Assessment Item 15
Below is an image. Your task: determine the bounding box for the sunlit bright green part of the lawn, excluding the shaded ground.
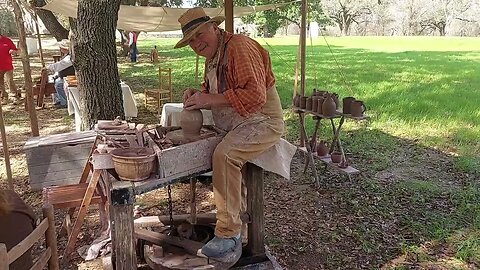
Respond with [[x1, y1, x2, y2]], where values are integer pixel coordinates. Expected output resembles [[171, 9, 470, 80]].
[[124, 37, 480, 171]]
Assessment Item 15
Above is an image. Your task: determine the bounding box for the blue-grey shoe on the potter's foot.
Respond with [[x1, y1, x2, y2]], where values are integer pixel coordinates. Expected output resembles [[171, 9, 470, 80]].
[[202, 234, 242, 261]]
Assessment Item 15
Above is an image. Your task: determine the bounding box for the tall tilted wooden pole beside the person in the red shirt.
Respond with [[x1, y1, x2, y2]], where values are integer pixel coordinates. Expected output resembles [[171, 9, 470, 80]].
[[10, 0, 39, 137]]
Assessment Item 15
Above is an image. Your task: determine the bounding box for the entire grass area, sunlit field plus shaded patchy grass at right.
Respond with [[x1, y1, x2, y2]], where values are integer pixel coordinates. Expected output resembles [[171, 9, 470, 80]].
[[119, 37, 480, 269]]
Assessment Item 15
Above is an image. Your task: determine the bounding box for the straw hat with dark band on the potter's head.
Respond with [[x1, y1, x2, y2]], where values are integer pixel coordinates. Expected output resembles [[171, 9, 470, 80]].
[[174, 7, 225, 49]]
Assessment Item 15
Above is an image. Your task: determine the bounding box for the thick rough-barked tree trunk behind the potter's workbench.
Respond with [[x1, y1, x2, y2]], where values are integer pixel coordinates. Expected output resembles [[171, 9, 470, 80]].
[[74, 0, 124, 129]]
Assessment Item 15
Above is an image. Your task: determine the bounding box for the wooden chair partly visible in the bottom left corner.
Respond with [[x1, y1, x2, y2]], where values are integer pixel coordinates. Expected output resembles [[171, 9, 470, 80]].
[[0, 205, 60, 270]]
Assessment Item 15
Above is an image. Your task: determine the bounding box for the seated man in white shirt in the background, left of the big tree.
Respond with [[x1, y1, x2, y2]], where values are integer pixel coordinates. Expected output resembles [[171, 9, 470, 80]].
[[48, 39, 75, 108]]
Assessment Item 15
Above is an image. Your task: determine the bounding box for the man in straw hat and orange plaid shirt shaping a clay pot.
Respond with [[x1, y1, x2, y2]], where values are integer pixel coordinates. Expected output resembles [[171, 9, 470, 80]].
[[175, 7, 284, 262]]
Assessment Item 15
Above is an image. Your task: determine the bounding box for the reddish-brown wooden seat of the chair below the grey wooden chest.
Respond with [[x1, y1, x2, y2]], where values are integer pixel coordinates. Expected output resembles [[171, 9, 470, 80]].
[[43, 183, 102, 209]]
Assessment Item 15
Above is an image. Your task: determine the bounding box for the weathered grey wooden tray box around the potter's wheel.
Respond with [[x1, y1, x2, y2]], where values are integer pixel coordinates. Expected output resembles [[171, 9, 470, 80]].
[[147, 126, 225, 178]]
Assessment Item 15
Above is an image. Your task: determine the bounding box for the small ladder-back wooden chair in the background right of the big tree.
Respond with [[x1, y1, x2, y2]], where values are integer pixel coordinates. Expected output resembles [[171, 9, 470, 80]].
[[145, 68, 173, 115]]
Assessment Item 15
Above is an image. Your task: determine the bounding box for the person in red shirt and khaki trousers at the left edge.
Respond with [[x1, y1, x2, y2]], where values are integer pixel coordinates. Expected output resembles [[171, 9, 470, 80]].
[[0, 32, 20, 101]]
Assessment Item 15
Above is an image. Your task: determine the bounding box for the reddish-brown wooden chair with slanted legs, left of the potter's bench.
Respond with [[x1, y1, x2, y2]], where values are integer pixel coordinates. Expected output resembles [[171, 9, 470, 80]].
[[43, 138, 108, 260]]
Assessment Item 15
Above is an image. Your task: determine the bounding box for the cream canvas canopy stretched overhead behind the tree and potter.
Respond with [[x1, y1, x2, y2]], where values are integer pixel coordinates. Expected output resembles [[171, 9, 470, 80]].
[[42, 0, 297, 32]]
